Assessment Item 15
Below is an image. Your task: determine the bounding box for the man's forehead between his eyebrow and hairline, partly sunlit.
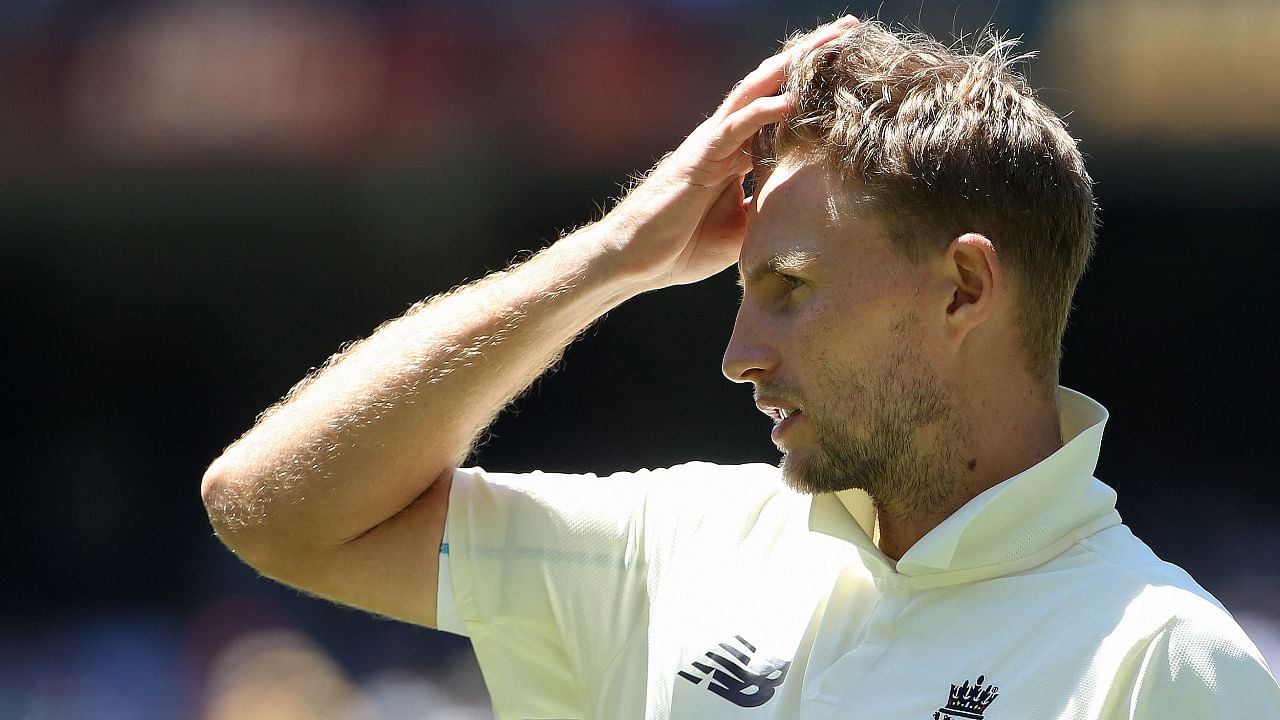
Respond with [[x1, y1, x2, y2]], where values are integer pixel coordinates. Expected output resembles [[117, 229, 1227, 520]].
[[739, 161, 890, 277]]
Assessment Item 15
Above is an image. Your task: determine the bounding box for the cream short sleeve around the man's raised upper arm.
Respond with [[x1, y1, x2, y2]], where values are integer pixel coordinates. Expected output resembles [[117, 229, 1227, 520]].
[[440, 461, 660, 717]]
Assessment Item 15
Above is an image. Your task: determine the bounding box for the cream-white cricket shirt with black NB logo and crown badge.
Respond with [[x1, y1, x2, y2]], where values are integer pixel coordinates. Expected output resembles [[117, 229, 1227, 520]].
[[439, 389, 1280, 720]]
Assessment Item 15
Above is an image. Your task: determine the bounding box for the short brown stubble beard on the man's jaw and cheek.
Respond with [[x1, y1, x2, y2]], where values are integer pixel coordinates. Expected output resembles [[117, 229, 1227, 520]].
[[783, 337, 968, 516]]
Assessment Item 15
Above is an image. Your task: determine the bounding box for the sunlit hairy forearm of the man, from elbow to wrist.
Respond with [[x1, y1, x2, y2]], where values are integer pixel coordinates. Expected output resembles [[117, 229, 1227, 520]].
[[202, 224, 641, 552]]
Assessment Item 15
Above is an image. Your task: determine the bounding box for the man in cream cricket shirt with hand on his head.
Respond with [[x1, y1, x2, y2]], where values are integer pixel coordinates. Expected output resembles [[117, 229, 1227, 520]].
[[202, 18, 1280, 720]]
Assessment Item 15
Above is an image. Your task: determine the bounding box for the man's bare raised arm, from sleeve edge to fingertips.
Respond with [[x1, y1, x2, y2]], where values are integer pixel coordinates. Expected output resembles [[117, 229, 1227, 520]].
[[201, 18, 854, 625]]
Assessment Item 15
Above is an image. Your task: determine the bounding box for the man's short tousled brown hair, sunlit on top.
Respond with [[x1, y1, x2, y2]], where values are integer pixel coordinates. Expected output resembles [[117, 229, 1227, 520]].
[[755, 22, 1097, 379]]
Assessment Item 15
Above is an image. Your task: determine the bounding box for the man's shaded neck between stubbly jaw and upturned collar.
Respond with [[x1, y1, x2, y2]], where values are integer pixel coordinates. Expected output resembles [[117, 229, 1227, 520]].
[[873, 387, 1062, 561]]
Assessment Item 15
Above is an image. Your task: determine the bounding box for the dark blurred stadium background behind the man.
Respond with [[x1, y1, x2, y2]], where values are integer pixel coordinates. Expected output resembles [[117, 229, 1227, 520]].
[[0, 0, 1280, 720]]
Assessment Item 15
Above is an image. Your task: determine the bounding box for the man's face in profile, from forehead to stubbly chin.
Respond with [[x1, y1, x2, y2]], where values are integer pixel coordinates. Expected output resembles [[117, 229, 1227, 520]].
[[723, 163, 965, 512]]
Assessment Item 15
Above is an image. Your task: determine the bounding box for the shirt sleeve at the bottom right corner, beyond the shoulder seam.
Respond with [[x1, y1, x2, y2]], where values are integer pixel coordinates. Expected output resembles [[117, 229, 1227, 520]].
[[1129, 611, 1280, 720]]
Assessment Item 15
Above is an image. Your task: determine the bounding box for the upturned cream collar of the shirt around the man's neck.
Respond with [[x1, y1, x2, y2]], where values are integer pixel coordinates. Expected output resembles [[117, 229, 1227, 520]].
[[809, 387, 1120, 584]]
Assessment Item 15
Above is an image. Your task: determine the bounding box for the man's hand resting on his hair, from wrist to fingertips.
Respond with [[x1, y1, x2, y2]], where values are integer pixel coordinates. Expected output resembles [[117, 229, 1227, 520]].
[[600, 15, 858, 290]]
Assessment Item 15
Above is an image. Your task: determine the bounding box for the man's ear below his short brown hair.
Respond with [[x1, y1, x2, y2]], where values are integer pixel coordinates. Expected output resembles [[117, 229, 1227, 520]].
[[943, 232, 1005, 340]]
